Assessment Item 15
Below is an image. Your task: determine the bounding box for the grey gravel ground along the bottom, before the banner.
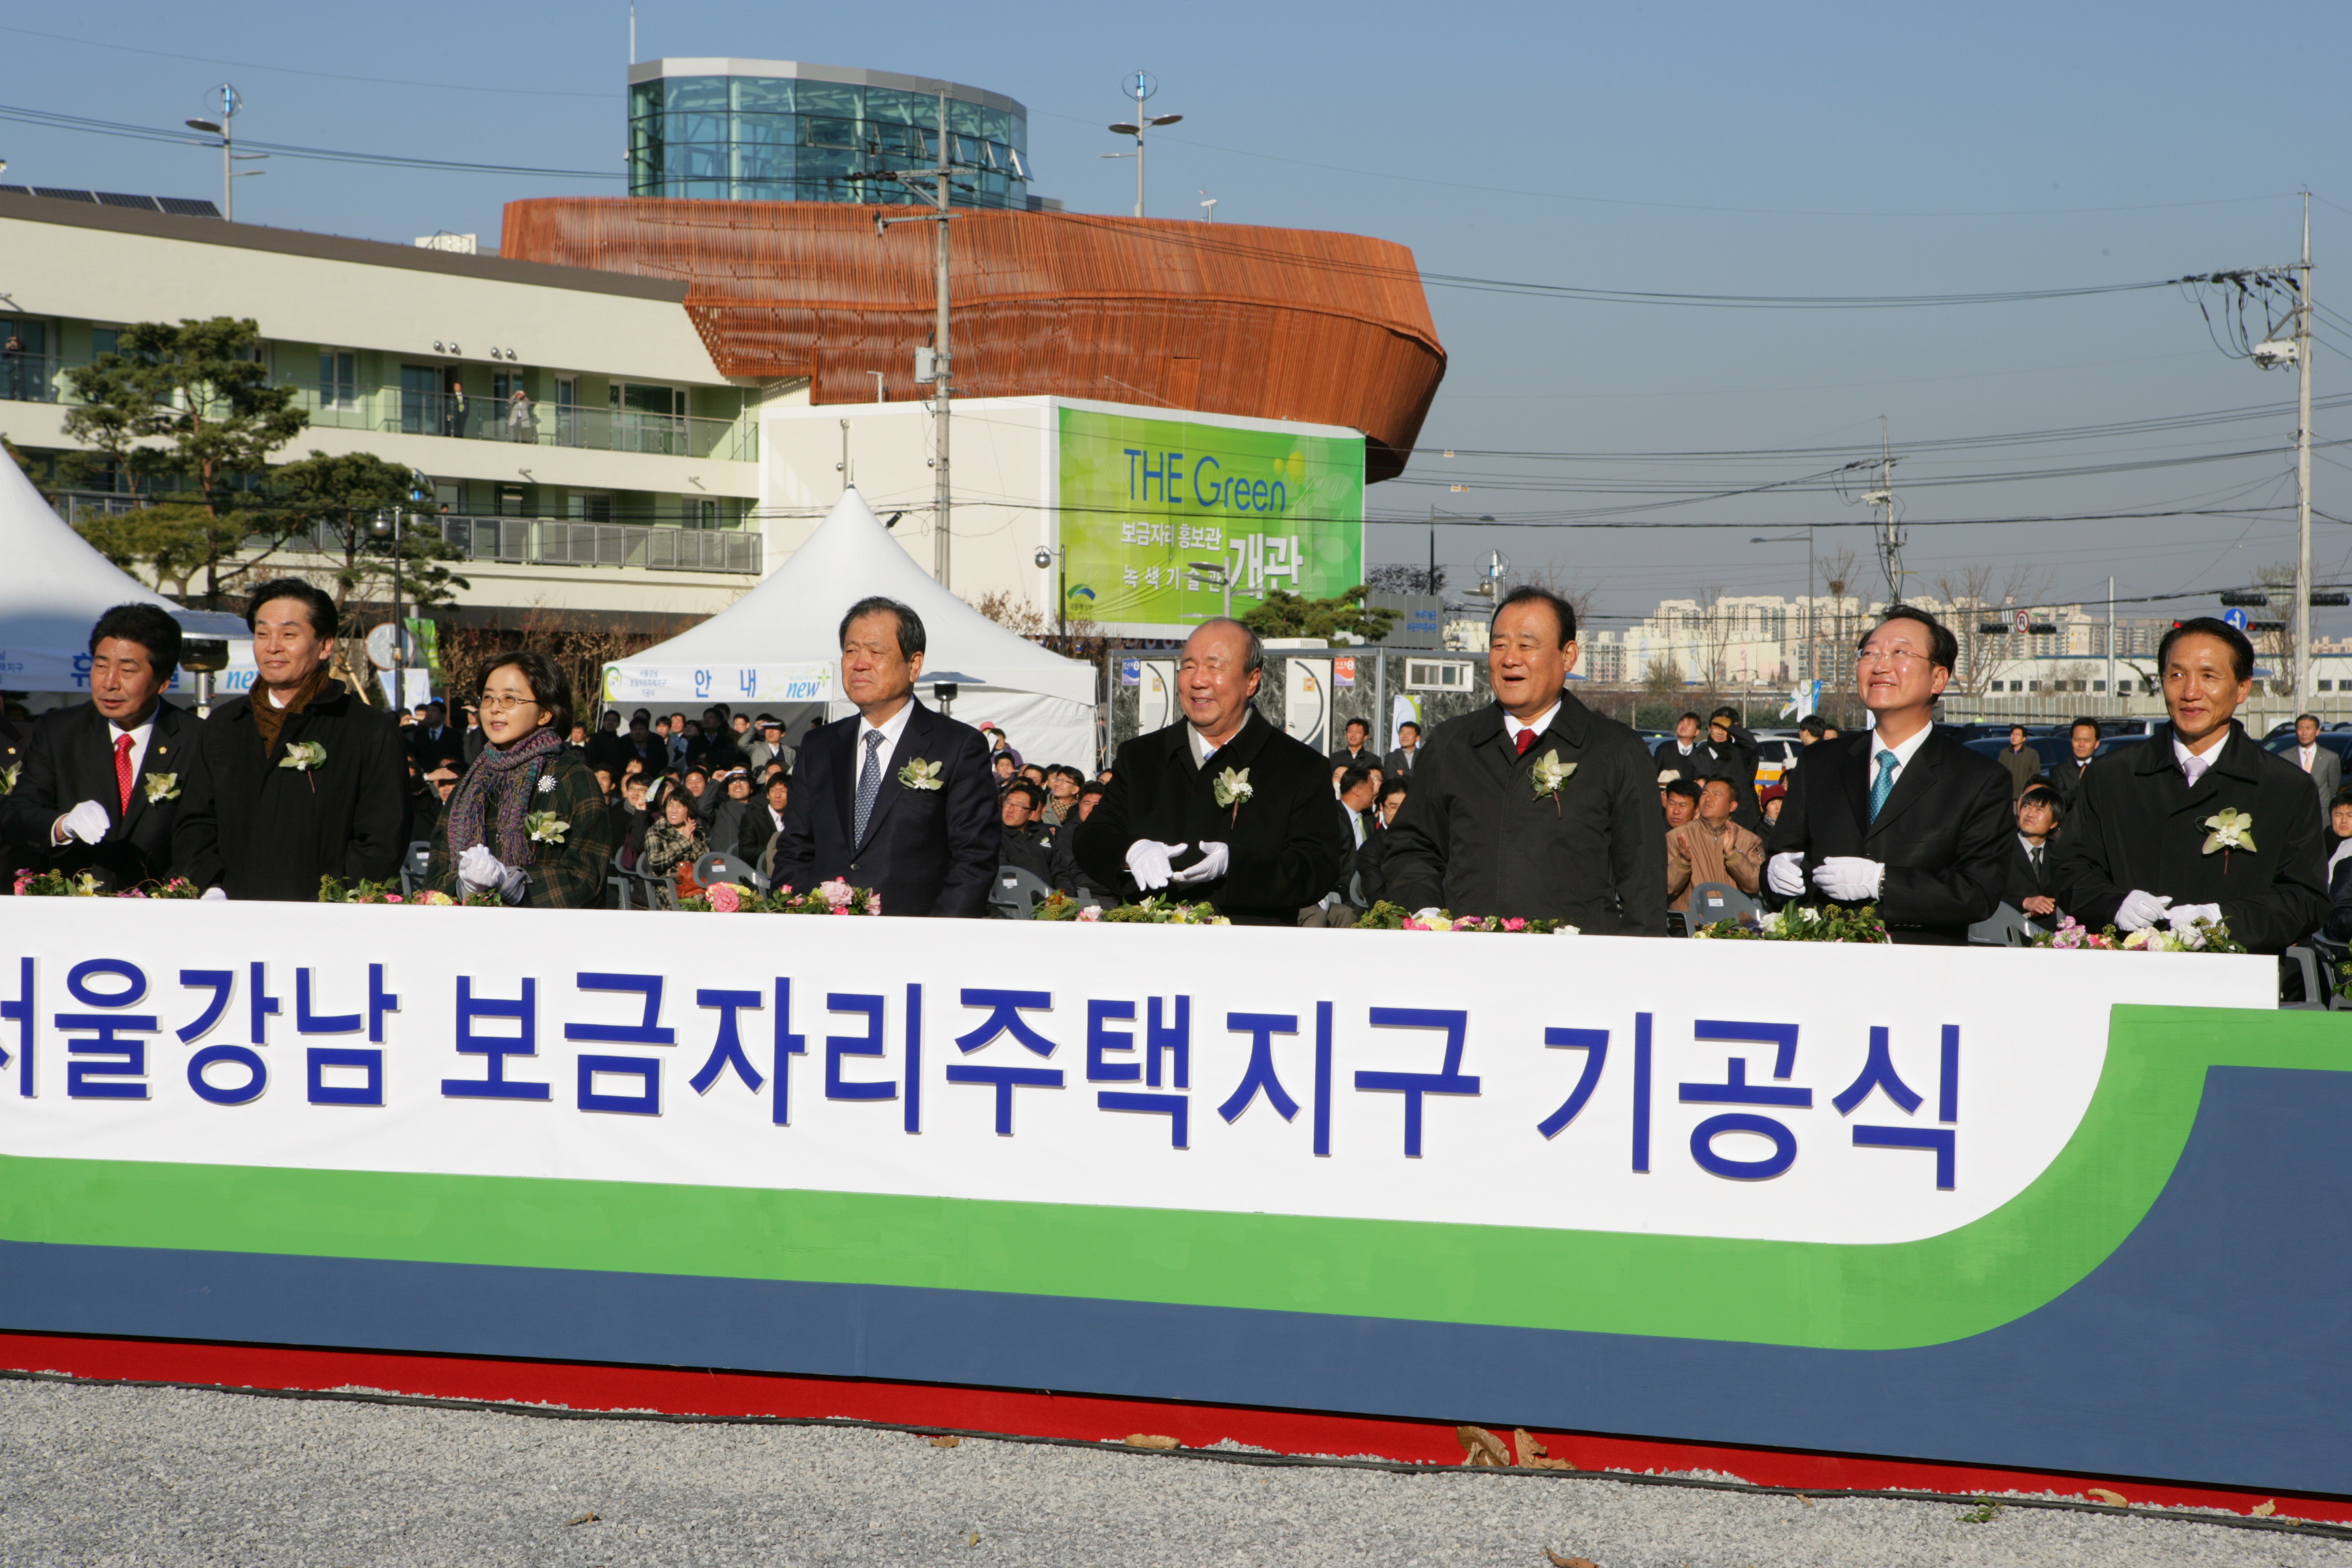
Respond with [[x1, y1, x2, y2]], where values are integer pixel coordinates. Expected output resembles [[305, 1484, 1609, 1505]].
[[0, 1382, 2352, 1568]]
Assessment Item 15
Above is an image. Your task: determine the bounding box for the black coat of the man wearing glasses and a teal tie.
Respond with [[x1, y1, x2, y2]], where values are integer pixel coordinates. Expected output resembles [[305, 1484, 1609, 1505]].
[[1767, 728, 2013, 945]]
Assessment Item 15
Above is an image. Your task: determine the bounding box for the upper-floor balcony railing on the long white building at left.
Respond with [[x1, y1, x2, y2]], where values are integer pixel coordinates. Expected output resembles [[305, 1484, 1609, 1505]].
[[0, 353, 760, 463]]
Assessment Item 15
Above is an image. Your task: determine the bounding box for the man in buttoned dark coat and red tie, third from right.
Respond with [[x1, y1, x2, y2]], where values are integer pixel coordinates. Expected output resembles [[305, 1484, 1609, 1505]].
[[1380, 588, 1665, 936]]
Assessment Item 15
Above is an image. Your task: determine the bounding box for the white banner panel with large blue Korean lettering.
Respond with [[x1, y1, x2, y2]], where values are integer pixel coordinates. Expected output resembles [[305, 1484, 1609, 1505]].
[[0, 898, 2274, 1243]]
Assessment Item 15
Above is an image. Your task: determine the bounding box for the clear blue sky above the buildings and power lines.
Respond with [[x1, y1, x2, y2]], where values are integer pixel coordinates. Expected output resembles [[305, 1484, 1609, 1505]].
[[0, 0, 2352, 630]]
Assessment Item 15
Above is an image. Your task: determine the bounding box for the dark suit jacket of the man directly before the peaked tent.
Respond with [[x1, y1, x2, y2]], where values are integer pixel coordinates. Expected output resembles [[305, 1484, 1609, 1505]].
[[774, 698, 1004, 919]]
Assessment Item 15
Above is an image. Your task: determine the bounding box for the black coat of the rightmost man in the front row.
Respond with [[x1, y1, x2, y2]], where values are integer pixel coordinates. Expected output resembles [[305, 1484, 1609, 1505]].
[[2055, 719, 2328, 952]]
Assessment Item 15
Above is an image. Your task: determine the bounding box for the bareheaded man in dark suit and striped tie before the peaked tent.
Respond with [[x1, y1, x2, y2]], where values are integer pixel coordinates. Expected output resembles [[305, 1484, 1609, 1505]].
[[776, 600, 1002, 917]]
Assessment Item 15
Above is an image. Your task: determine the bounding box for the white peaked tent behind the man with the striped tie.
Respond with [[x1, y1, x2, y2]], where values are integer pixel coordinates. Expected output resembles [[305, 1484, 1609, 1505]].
[[604, 487, 1096, 774]]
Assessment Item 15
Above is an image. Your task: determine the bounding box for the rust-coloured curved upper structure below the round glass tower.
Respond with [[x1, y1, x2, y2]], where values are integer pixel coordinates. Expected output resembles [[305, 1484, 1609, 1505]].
[[498, 197, 1446, 480]]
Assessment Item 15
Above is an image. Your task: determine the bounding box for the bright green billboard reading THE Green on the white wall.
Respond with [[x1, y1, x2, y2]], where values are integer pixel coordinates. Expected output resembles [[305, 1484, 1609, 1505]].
[[1061, 409, 1364, 625]]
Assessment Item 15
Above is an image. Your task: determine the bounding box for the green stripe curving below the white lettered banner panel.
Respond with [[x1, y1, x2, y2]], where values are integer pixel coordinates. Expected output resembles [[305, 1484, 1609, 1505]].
[[0, 1011, 2352, 1349]]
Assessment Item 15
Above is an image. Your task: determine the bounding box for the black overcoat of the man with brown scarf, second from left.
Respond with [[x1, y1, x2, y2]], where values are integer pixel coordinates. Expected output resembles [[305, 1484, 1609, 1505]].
[[172, 681, 407, 903]]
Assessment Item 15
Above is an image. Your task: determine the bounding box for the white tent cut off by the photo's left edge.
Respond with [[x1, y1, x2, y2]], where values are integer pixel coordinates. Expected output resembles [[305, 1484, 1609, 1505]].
[[0, 459, 252, 693]]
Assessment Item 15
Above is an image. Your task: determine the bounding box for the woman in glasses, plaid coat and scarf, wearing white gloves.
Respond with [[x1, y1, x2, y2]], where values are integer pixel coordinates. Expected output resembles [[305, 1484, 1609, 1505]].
[[426, 649, 612, 910]]
